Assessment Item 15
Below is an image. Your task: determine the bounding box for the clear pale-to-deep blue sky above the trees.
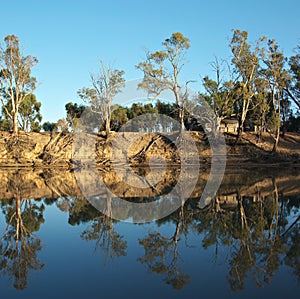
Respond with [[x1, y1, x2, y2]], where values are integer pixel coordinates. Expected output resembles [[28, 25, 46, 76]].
[[0, 0, 300, 121]]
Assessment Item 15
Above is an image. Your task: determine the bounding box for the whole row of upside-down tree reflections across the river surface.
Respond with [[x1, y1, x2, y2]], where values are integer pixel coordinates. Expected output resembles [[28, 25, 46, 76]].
[[0, 171, 300, 291]]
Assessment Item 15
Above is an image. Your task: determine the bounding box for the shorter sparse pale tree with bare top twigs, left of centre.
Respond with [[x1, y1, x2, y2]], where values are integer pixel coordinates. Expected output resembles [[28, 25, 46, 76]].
[[78, 61, 125, 136]]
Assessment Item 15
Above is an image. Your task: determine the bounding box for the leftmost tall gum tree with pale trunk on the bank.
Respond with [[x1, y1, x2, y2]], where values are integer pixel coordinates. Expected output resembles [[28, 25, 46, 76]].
[[0, 35, 38, 134]]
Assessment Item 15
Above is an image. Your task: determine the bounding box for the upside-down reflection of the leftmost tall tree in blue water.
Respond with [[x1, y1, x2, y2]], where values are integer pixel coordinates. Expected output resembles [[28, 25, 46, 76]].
[[0, 197, 44, 290]]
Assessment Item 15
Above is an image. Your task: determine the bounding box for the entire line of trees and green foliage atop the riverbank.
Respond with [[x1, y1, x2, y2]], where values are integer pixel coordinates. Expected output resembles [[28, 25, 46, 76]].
[[0, 29, 300, 139]]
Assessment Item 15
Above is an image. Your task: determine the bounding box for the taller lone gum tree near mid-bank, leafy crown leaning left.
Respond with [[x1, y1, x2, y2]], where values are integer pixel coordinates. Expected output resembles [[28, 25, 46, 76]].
[[137, 32, 190, 134]]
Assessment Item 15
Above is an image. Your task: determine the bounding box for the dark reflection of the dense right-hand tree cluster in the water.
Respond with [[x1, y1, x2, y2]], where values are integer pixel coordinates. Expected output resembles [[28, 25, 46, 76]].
[[193, 181, 300, 291]]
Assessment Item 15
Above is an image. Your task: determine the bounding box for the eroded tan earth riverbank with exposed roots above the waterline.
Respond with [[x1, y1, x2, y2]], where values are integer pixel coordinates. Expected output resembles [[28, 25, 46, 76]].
[[0, 132, 300, 169]]
